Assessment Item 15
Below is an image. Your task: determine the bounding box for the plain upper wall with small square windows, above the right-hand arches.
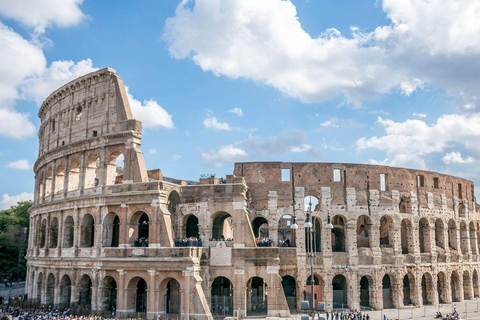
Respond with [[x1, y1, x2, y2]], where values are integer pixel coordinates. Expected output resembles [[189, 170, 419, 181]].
[[234, 162, 475, 211]]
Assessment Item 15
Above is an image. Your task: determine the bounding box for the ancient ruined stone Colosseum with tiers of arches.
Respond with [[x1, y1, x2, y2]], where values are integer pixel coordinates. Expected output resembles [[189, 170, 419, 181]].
[[26, 68, 480, 319]]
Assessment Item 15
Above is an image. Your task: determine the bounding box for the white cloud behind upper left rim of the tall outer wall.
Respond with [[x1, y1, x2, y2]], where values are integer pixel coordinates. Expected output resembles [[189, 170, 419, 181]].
[[21, 59, 98, 104]]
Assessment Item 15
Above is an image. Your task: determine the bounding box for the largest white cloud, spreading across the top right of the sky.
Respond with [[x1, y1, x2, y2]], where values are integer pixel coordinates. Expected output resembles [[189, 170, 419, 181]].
[[164, 0, 480, 109]]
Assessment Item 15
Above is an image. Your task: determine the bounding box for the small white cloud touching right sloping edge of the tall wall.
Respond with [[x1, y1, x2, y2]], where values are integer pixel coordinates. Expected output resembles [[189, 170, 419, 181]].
[[126, 87, 175, 129]]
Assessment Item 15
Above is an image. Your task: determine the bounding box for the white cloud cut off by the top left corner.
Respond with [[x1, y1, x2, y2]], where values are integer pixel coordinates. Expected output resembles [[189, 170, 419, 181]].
[[0, 0, 85, 34]]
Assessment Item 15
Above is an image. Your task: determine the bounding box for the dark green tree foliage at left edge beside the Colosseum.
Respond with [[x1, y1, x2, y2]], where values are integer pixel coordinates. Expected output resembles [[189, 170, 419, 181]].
[[0, 201, 32, 280]]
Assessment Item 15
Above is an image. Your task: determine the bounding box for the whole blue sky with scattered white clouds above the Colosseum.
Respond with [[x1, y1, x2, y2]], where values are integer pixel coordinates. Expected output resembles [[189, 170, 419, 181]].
[[0, 0, 480, 209]]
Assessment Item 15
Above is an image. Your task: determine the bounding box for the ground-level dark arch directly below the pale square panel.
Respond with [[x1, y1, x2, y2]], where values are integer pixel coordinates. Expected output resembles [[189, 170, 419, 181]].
[[211, 277, 233, 317]]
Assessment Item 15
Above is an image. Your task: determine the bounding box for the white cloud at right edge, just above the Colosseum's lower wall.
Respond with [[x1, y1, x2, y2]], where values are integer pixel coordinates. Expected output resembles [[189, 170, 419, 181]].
[[356, 114, 480, 168]]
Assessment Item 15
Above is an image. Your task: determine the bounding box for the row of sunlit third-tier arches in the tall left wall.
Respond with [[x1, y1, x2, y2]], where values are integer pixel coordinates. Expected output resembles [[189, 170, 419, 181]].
[[37, 150, 124, 199]]
